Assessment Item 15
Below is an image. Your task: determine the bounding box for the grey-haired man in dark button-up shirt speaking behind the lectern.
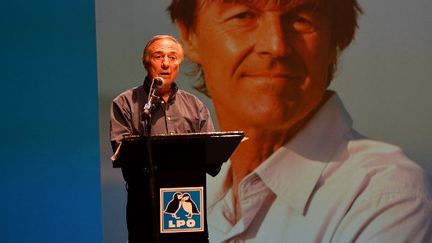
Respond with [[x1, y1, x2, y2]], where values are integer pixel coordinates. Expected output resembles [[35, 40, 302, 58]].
[[110, 35, 214, 243]]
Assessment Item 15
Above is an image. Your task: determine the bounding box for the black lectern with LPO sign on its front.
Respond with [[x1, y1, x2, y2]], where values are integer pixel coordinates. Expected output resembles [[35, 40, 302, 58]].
[[113, 131, 244, 243]]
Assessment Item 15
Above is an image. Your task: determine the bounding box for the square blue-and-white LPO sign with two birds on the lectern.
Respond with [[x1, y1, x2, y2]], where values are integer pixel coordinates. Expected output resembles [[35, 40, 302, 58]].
[[160, 187, 204, 233]]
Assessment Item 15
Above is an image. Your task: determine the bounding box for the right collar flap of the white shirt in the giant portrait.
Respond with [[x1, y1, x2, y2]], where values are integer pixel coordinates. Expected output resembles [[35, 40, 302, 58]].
[[255, 93, 352, 214]]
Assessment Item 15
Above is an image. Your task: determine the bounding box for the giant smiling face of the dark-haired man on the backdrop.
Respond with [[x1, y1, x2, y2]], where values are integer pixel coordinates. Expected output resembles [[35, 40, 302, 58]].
[[180, 1, 336, 129]]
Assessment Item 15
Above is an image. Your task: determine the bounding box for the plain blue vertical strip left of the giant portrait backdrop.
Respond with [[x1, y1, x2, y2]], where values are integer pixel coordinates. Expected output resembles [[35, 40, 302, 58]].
[[0, 0, 102, 243]]
